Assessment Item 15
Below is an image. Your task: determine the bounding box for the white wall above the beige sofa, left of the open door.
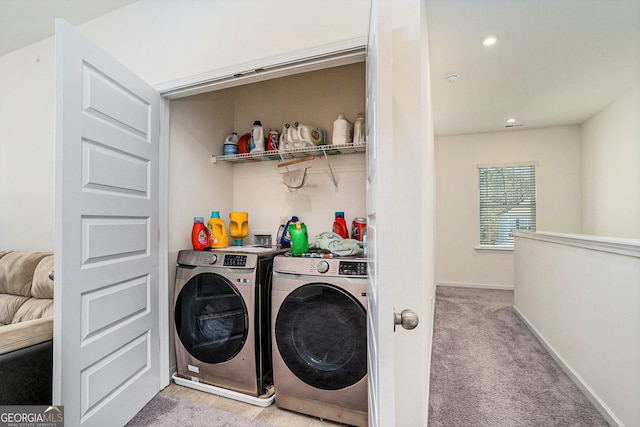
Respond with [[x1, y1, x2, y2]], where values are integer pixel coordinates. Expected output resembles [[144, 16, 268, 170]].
[[0, 39, 55, 251]]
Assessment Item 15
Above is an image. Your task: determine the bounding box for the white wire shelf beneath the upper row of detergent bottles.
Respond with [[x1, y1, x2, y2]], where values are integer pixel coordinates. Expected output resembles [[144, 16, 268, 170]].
[[211, 143, 367, 163]]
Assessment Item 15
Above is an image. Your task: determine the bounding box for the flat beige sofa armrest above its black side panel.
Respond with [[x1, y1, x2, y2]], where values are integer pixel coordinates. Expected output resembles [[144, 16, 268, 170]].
[[0, 317, 53, 354]]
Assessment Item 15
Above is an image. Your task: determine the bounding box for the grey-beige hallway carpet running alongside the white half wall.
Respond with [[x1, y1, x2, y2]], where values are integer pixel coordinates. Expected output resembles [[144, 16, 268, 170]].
[[429, 287, 608, 427]]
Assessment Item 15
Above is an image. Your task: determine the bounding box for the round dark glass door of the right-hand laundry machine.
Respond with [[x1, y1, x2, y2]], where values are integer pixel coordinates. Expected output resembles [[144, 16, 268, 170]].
[[275, 283, 367, 390]]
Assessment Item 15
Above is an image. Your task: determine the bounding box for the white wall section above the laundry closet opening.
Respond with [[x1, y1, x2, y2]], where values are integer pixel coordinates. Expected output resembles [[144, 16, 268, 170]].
[[79, 0, 369, 88]]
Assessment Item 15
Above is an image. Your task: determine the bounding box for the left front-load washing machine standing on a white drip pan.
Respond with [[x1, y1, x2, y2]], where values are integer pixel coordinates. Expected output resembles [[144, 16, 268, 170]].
[[173, 247, 283, 406]]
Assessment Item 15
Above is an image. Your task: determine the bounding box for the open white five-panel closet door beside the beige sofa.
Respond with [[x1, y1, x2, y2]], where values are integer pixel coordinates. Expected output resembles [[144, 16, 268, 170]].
[[53, 20, 160, 426]]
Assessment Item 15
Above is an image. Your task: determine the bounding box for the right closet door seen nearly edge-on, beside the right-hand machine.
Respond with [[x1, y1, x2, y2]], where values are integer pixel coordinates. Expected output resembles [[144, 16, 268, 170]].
[[366, 0, 395, 427]]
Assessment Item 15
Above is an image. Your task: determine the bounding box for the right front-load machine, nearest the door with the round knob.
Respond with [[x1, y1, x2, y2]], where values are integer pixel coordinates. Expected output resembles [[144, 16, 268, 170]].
[[271, 255, 368, 426]]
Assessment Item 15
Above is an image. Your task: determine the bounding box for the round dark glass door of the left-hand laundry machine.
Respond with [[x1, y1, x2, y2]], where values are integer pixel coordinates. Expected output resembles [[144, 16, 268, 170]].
[[175, 273, 249, 363]]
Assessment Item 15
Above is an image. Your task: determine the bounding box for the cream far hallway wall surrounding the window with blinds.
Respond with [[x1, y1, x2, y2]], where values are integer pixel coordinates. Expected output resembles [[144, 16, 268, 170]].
[[435, 126, 582, 287]]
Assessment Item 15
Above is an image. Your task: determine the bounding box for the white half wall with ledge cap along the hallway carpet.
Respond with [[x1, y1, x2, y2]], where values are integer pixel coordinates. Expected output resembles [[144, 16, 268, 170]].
[[514, 233, 640, 427]]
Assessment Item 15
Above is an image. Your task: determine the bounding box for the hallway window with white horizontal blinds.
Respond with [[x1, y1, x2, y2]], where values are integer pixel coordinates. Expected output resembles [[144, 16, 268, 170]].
[[478, 165, 536, 247]]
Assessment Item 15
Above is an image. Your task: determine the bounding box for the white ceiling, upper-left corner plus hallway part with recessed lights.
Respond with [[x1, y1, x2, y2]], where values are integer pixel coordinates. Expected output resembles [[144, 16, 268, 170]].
[[0, 0, 640, 135]]
